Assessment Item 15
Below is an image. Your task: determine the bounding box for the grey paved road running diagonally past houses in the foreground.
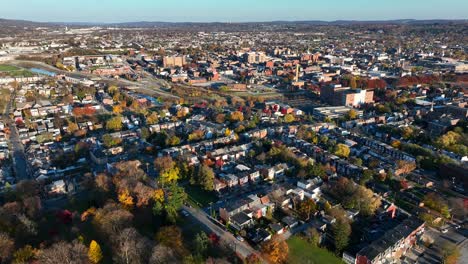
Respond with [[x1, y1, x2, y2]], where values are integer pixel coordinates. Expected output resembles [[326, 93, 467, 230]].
[[183, 206, 266, 263]]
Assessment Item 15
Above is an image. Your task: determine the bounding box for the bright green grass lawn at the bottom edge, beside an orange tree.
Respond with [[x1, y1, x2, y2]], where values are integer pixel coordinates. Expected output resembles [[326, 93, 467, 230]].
[[287, 236, 344, 264]]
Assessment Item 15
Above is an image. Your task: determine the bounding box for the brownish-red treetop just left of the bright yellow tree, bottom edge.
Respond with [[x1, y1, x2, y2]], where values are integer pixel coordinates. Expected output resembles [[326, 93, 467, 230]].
[[39, 240, 89, 264]]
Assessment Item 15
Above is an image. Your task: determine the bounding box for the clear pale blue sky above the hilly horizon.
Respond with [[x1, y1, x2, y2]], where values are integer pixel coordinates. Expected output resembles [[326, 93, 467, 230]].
[[0, 0, 468, 23]]
